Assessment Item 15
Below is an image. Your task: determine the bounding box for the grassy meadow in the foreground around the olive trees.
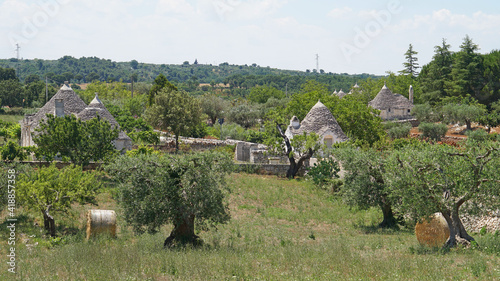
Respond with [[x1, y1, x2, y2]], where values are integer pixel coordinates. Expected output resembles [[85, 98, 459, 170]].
[[0, 174, 500, 280]]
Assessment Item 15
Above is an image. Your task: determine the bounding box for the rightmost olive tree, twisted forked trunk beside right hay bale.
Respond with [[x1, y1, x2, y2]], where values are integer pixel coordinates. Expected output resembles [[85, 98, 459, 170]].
[[387, 140, 500, 246]]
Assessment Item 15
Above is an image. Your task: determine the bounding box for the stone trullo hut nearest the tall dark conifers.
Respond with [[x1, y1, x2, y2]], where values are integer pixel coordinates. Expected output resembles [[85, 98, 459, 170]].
[[368, 84, 413, 120]]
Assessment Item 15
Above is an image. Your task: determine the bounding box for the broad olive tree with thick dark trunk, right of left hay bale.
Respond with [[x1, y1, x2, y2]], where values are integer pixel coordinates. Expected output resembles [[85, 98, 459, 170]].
[[105, 152, 231, 246]]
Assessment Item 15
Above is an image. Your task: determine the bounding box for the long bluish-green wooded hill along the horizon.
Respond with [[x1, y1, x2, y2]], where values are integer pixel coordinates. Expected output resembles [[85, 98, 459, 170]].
[[0, 56, 377, 89]]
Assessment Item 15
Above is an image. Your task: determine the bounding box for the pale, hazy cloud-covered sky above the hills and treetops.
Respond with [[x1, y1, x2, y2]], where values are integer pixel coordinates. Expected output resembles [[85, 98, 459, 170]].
[[0, 0, 500, 75]]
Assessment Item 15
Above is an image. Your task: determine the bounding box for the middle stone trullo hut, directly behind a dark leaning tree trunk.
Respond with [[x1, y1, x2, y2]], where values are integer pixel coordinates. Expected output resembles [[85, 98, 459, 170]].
[[285, 101, 349, 147]]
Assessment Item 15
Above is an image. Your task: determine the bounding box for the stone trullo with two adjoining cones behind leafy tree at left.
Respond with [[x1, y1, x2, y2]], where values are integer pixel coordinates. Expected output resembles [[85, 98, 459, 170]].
[[20, 82, 132, 151]]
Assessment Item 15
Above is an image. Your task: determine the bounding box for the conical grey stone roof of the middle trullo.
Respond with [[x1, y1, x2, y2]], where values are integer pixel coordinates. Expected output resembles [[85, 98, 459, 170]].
[[288, 101, 349, 141]]
